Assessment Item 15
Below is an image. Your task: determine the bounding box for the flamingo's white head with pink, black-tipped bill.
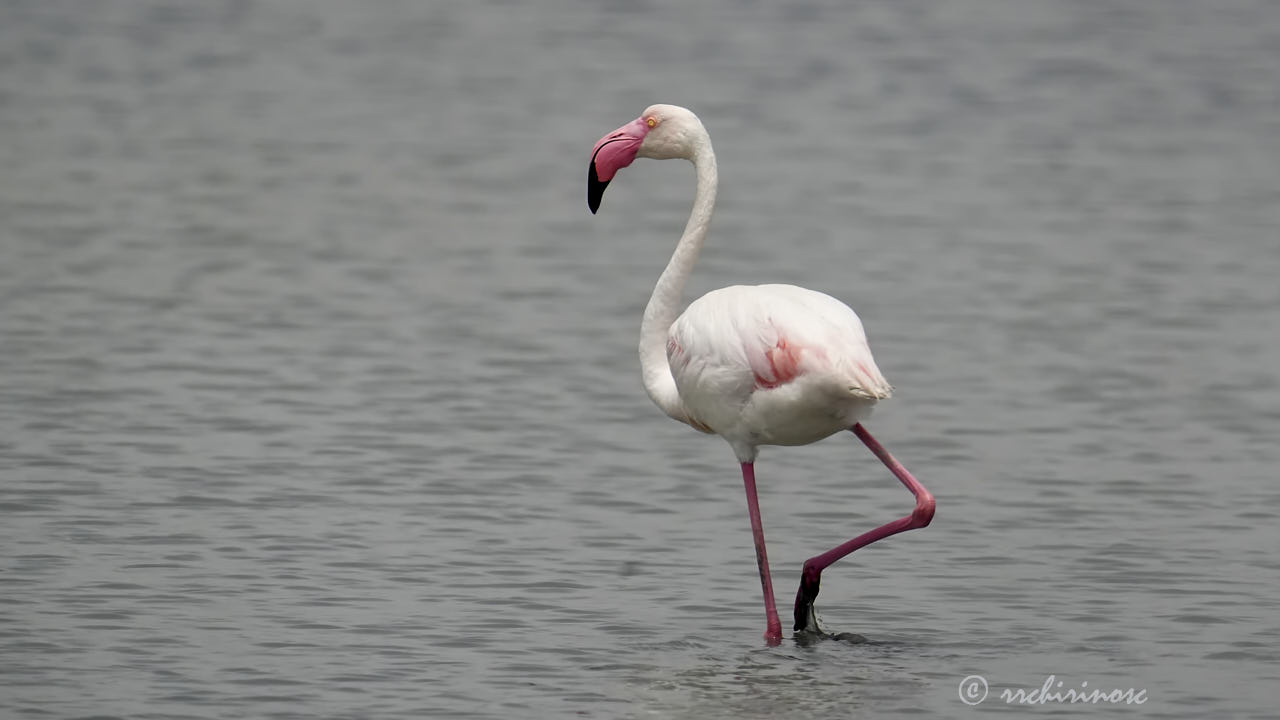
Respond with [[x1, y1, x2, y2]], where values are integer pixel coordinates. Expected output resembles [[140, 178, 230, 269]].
[[586, 105, 707, 214]]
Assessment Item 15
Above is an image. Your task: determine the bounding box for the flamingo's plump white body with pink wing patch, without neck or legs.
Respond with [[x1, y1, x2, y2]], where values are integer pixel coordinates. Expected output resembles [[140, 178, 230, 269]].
[[667, 284, 891, 462]]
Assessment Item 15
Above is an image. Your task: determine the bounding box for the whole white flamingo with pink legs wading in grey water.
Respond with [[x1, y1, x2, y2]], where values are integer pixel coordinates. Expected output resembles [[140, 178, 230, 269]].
[[586, 105, 934, 646]]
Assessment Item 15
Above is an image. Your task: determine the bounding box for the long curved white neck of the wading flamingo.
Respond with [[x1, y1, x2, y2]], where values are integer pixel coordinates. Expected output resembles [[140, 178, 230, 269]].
[[640, 131, 717, 421]]
